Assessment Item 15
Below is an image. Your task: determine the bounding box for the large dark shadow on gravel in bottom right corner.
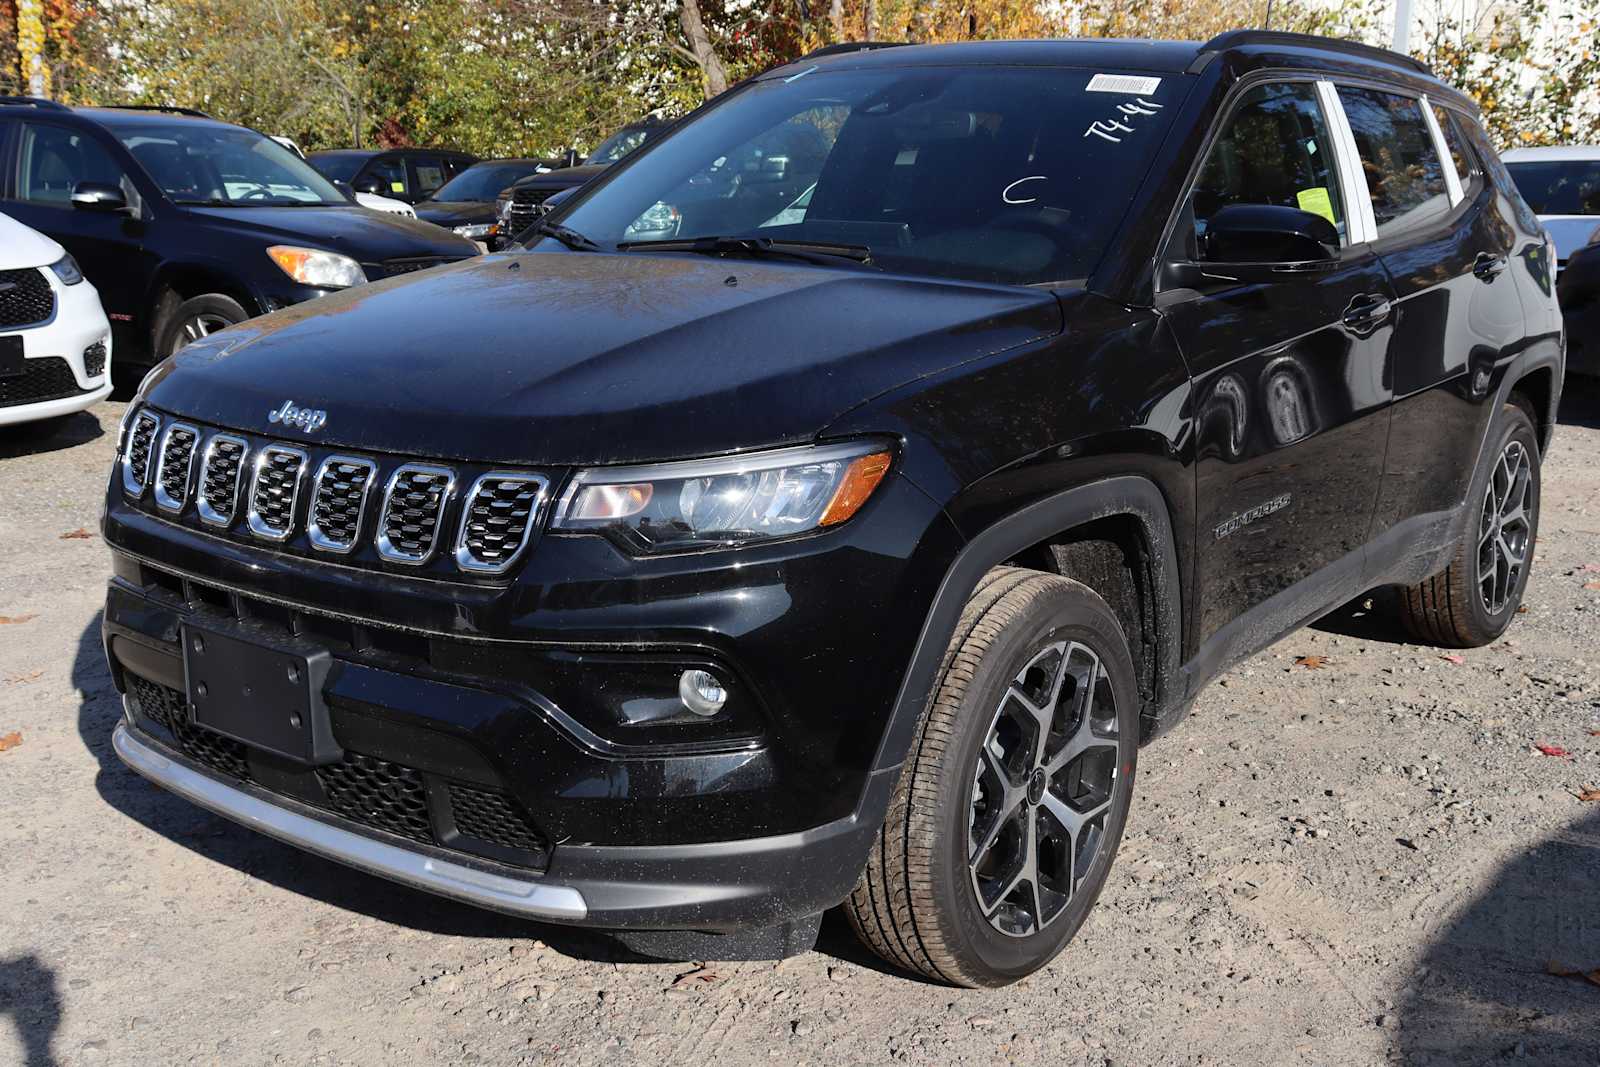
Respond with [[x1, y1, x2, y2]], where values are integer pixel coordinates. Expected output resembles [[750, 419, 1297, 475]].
[[1397, 806, 1600, 1067]]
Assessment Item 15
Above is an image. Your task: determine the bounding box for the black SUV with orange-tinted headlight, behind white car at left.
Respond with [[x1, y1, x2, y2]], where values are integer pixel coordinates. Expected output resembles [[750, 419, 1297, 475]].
[[0, 98, 478, 363]]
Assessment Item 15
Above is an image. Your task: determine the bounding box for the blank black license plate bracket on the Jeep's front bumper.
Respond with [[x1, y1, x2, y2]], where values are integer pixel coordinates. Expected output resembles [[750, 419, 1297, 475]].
[[179, 622, 344, 766]]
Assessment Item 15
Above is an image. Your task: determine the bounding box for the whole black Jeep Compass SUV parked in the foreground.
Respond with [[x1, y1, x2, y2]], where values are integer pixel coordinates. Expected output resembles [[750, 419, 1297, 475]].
[[104, 32, 1563, 984]]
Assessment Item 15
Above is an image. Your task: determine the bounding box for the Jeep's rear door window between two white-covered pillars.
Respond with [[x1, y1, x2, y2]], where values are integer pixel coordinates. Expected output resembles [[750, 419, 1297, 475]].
[[1339, 85, 1450, 240]]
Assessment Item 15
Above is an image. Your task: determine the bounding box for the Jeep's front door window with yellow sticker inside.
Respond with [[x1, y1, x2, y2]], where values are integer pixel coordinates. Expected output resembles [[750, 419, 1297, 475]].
[[1189, 82, 1349, 246]]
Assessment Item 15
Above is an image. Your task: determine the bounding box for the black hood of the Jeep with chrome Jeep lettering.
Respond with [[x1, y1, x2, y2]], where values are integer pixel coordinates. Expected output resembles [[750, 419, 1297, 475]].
[[140, 253, 1061, 466]]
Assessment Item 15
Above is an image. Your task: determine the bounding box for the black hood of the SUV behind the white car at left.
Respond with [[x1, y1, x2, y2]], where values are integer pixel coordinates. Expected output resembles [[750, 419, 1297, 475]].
[[186, 203, 478, 262]]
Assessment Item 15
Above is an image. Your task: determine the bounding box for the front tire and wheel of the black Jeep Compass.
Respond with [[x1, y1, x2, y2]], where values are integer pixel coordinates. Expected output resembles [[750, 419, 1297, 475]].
[[845, 568, 1139, 985]]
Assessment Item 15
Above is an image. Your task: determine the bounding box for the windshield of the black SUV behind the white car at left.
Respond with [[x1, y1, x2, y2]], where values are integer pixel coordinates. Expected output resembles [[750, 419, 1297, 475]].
[[107, 122, 349, 206]]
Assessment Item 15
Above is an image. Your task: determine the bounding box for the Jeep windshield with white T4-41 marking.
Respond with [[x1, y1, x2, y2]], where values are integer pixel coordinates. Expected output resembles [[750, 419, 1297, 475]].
[[558, 67, 1182, 285]]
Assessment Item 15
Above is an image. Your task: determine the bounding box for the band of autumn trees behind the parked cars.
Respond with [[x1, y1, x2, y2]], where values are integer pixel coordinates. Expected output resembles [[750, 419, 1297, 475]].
[[12, 0, 1600, 155]]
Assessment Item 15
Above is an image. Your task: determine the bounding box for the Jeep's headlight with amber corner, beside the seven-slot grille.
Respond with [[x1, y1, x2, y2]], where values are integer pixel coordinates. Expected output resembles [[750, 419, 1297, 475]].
[[555, 442, 893, 552]]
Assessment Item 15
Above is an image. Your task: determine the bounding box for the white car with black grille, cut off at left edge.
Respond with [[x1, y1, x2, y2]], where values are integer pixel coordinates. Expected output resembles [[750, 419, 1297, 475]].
[[0, 214, 110, 426]]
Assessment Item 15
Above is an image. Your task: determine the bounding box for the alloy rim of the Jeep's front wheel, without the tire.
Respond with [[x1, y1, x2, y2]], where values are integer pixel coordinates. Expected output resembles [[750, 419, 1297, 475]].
[[968, 641, 1118, 937]]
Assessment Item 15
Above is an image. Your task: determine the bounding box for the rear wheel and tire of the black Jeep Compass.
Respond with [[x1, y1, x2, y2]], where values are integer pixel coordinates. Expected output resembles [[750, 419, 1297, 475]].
[[1400, 403, 1539, 648]]
